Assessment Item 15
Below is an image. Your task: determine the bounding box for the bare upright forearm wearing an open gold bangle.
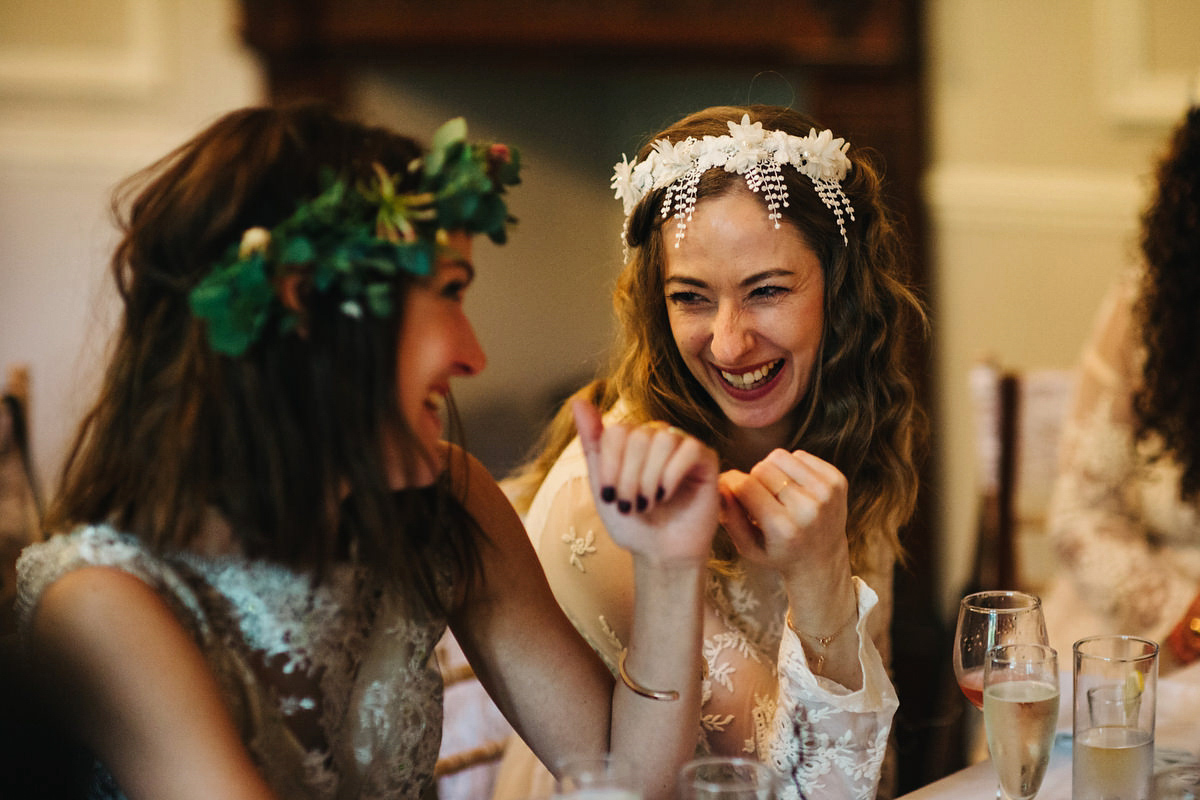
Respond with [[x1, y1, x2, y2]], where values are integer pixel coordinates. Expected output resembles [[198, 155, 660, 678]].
[[612, 559, 706, 800]]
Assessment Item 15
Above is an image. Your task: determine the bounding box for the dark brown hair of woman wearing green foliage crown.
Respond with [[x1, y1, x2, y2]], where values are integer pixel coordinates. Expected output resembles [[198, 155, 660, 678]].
[[47, 104, 479, 612]]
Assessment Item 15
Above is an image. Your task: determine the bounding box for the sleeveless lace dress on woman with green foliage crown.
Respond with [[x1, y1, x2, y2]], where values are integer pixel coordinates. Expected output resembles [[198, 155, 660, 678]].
[[18, 525, 445, 800]]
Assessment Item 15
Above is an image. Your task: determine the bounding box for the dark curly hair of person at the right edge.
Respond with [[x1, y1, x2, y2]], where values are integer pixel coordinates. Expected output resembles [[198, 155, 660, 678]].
[[1134, 107, 1200, 500]]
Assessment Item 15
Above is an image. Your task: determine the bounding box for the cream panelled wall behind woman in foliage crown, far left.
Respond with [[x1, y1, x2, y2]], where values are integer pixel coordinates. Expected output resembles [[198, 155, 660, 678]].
[[0, 0, 263, 488]]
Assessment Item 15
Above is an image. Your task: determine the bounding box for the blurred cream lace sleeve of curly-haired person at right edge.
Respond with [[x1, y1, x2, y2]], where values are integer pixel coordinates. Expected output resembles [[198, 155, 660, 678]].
[[1048, 282, 1196, 639]]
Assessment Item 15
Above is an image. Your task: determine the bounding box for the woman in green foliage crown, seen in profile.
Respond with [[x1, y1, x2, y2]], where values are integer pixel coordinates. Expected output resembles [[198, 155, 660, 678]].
[[11, 106, 719, 800]]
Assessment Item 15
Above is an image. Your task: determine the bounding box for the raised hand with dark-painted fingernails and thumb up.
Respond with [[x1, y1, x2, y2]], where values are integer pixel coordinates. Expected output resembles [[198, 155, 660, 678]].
[[571, 399, 720, 565]]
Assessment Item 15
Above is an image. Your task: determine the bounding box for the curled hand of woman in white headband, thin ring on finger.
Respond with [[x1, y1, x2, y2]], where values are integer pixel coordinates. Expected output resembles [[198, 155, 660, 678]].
[[720, 450, 850, 583]]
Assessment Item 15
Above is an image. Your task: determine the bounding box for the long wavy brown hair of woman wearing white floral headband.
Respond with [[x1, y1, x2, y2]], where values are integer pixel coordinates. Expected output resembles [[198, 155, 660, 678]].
[[512, 106, 928, 571]]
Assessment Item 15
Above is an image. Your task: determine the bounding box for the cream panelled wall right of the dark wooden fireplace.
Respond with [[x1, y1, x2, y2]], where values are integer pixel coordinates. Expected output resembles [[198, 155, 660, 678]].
[[926, 0, 1200, 613]]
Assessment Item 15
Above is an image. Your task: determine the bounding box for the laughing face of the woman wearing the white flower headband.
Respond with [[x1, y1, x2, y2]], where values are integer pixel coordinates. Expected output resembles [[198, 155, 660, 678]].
[[662, 190, 824, 445]]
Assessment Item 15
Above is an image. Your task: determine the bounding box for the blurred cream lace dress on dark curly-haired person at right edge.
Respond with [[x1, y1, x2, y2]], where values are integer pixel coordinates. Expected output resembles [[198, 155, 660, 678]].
[[1044, 275, 1200, 658]]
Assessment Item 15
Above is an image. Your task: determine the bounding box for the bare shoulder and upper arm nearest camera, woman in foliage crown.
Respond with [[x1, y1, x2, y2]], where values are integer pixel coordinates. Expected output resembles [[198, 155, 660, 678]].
[[30, 566, 271, 800]]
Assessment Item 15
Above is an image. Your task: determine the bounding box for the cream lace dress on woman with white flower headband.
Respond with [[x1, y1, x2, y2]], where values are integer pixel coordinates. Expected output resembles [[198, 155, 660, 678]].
[[496, 422, 898, 800]]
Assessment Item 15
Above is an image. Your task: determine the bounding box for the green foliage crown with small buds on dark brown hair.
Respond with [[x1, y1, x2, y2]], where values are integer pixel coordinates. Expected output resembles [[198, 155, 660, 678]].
[[188, 118, 521, 356]]
